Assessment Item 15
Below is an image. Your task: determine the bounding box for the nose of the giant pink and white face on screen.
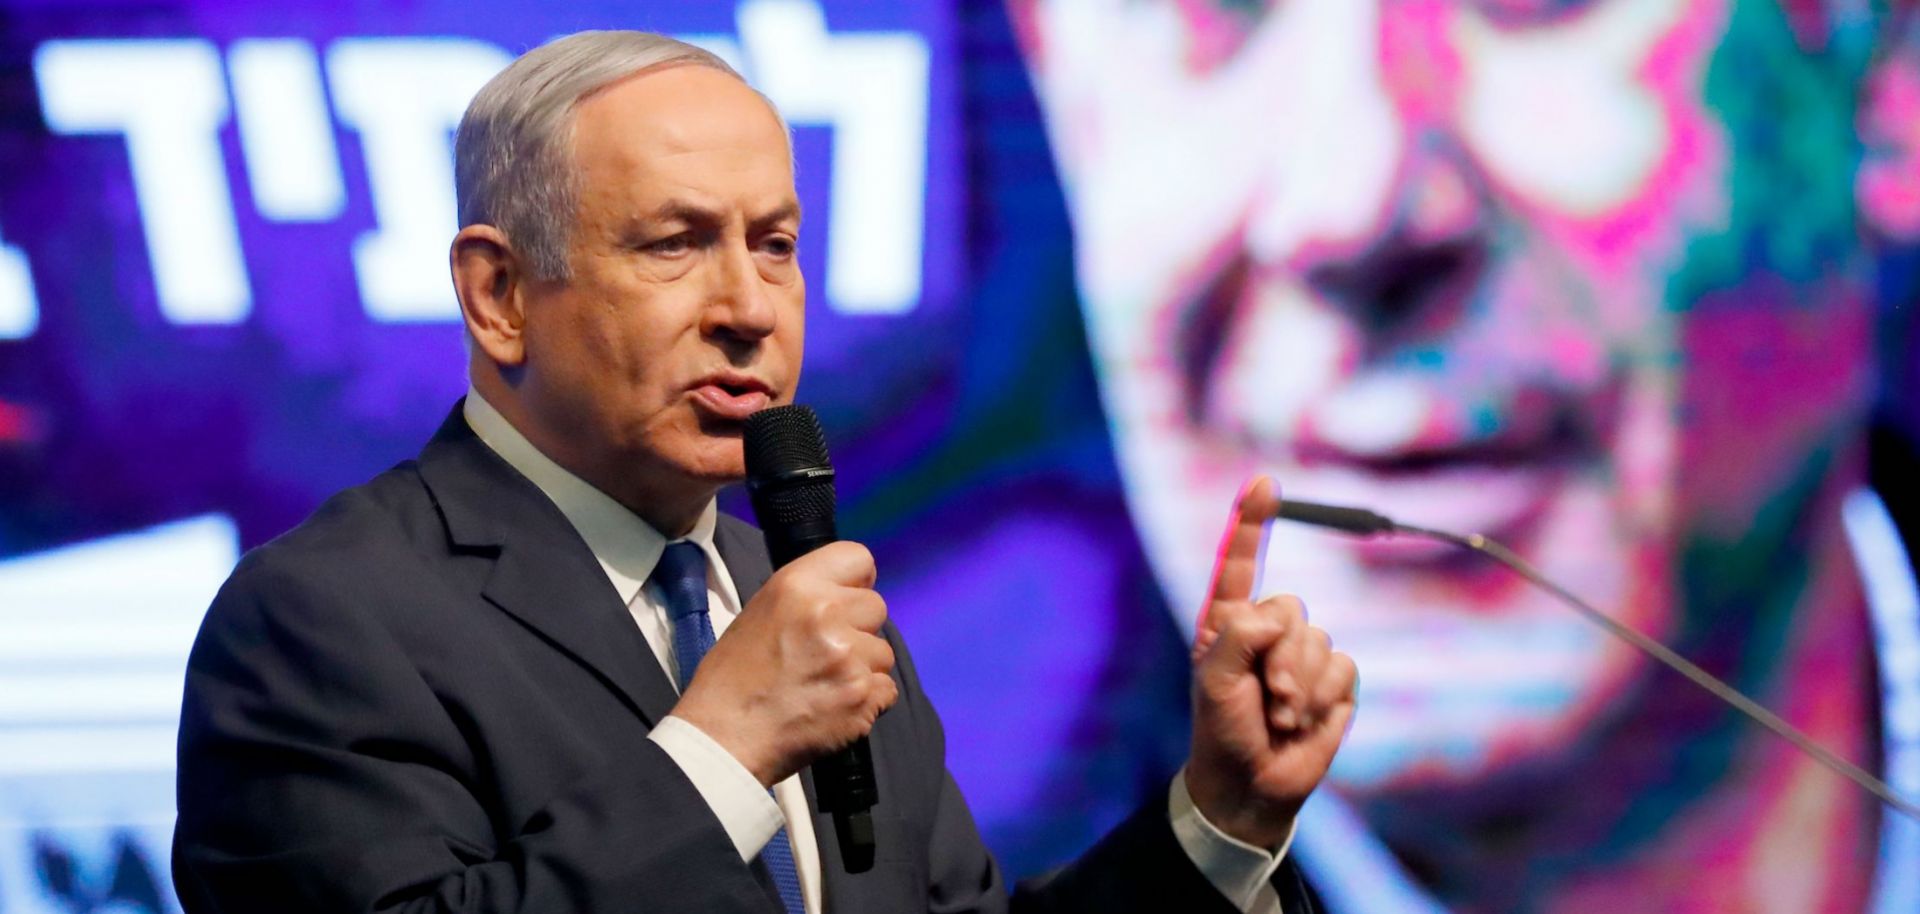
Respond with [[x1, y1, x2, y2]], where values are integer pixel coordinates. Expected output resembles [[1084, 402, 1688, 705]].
[[1246, 0, 1490, 332]]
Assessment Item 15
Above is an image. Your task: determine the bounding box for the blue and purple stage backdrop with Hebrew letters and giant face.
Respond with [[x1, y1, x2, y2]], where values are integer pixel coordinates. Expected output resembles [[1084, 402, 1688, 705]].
[[0, 0, 1920, 914]]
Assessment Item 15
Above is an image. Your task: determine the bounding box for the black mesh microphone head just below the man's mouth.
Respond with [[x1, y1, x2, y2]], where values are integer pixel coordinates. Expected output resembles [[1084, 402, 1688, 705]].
[[741, 403, 839, 566]]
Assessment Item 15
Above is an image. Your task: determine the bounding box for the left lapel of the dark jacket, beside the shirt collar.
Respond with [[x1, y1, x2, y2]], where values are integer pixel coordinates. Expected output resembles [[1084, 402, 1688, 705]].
[[419, 403, 683, 726]]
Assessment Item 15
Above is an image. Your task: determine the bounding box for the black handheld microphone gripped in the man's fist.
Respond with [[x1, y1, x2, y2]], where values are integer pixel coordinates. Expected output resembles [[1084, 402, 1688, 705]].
[[745, 403, 879, 874]]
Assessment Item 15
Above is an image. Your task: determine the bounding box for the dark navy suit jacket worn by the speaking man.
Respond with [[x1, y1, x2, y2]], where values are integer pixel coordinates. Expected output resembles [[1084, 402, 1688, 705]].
[[173, 407, 1313, 914]]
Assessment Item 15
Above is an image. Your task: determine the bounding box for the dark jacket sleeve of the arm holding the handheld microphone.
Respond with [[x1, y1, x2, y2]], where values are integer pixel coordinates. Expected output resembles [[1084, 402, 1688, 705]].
[[173, 553, 766, 914]]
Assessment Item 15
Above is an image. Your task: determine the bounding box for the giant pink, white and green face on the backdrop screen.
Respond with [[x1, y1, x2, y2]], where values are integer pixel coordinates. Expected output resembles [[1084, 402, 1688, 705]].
[[1016, 0, 1866, 789]]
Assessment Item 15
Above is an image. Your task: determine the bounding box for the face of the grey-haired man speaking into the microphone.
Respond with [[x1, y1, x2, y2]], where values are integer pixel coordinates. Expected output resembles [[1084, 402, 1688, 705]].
[[522, 65, 806, 488]]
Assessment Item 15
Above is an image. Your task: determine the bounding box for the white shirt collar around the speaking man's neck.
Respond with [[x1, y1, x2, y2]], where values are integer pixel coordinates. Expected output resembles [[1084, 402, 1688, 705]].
[[463, 386, 739, 607]]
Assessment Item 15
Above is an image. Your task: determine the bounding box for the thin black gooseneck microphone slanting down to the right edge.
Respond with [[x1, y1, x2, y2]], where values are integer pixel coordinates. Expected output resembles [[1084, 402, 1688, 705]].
[[1273, 499, 1920, 820]]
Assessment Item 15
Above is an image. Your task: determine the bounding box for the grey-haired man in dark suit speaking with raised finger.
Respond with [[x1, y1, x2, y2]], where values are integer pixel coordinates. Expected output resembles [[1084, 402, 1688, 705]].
[[175, 33, 1354, 914]]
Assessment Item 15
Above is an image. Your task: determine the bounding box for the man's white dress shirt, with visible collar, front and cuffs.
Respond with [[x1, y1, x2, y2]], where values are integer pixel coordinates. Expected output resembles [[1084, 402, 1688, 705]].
[[465, 388, 1292, 914]]
